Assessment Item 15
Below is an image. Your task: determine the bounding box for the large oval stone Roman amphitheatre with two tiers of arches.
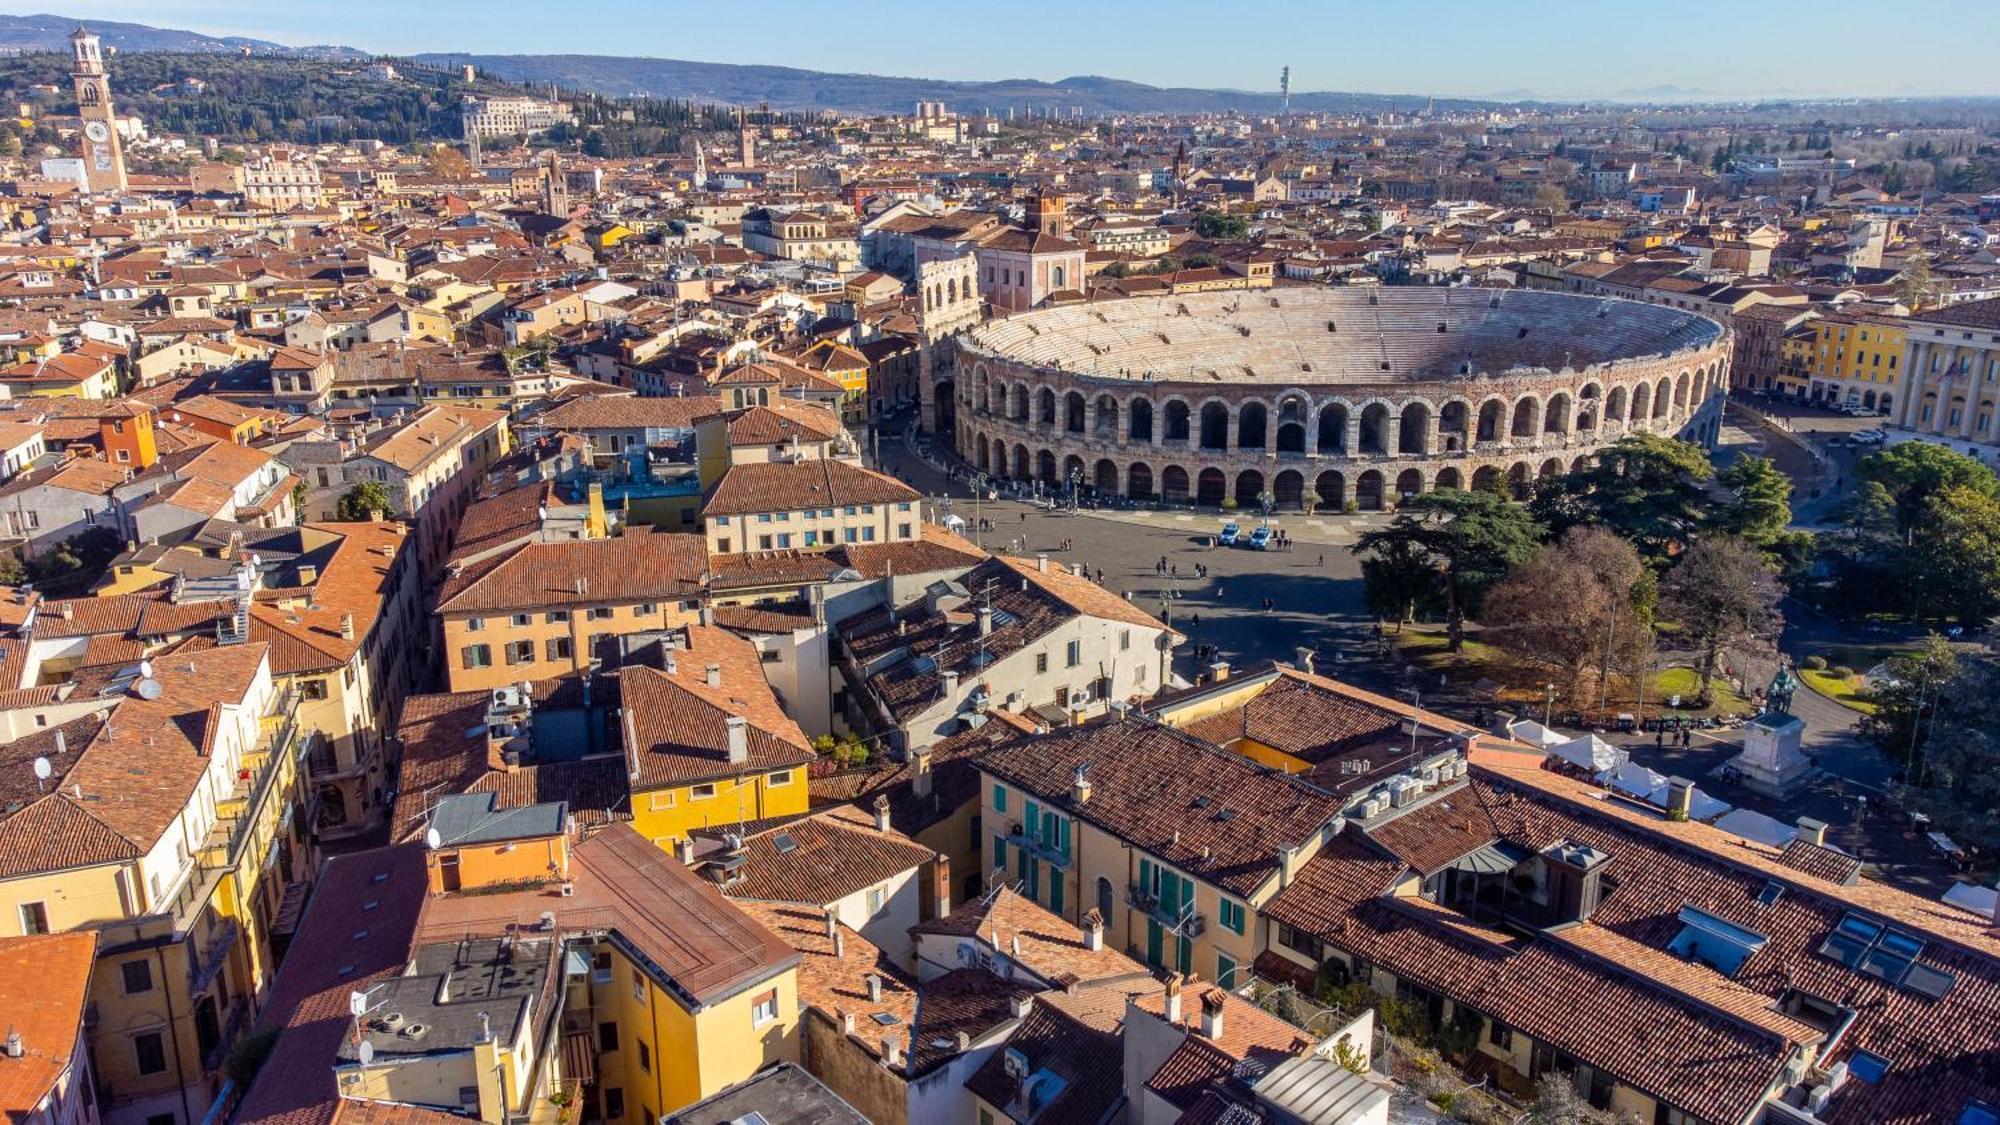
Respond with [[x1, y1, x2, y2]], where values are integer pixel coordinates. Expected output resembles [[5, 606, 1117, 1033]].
[[936, 288, 1730, 510]]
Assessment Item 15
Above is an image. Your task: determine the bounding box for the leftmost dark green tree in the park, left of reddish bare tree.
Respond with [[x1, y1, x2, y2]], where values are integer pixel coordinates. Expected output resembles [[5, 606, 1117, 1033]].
[[1352, 490, 1542, 653]]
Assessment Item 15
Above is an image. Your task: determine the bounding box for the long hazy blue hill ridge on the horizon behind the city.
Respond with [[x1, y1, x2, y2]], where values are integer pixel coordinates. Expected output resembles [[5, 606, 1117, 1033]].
[[416, 54, 1492, 114]]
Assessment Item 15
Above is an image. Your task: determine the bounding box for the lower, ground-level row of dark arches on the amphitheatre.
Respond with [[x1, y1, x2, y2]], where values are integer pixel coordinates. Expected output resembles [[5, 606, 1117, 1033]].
[[970, 434, 1590, 510]]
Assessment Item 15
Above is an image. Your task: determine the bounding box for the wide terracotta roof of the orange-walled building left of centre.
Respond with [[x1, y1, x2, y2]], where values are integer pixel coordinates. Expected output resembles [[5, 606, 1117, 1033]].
[[438, 530, 708, 613]]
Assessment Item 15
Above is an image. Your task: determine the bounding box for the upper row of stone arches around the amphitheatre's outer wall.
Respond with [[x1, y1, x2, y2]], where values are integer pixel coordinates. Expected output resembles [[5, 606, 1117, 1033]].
[[964, 362, 1724, 456]]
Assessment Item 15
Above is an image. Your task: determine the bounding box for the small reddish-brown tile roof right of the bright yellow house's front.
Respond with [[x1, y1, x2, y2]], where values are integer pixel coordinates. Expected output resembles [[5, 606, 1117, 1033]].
[[724, 805, 936, 907]]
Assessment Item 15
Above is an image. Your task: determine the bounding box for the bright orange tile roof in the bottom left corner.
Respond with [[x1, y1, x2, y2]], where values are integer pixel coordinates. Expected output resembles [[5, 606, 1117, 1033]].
[[0, 931, 98, 1121]]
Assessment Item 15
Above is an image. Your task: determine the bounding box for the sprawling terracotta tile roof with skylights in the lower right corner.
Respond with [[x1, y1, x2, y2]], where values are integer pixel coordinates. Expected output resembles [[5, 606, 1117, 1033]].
[[1266, 765, 2000, 1123]]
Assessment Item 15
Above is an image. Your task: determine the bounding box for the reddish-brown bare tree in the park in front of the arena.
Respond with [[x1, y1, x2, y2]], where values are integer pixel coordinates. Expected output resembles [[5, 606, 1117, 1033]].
[[1480, 526, 1654, 701]]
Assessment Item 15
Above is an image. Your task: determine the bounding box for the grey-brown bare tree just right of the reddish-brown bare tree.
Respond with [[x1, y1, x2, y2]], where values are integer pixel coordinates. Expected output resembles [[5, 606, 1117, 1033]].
[[1660, 534, 1784, 699]]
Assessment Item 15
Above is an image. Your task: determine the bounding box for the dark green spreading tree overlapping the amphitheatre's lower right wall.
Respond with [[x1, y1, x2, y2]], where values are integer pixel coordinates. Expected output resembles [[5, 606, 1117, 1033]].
[[1530, 434, 1714, 567]]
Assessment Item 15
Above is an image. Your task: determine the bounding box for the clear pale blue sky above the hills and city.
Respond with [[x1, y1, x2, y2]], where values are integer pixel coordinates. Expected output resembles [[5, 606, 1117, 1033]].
[[60, 0, 2000, 96]]
